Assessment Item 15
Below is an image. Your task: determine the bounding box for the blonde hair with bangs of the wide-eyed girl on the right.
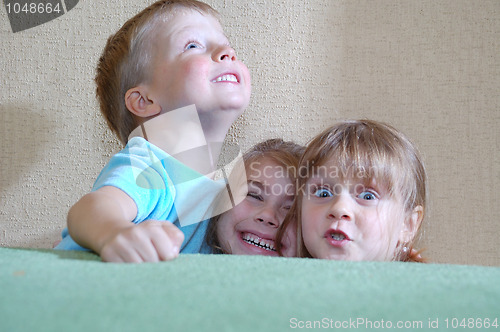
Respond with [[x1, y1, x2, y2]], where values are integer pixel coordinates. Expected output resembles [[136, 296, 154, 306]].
[[277, 120, 427, 260]]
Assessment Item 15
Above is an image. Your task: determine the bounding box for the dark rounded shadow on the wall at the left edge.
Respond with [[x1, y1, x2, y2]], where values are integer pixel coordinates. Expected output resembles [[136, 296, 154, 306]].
[[0, 104, 55, 192]]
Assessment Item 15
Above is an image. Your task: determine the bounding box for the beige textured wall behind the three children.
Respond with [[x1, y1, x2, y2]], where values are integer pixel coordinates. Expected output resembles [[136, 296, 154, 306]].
[[0, 0, 500, 265]]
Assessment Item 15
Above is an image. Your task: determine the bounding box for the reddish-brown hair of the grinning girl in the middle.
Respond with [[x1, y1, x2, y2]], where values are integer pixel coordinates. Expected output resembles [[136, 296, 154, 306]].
[[205, 138, 305, 254]]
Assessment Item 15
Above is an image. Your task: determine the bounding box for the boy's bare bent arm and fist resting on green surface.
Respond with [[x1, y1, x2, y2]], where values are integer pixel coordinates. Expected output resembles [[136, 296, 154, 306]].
[[68, 186, 184, 263]]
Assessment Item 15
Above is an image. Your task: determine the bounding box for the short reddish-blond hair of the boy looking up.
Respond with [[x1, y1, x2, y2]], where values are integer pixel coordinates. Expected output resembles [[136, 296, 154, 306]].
[[95, 0, 219, 145]]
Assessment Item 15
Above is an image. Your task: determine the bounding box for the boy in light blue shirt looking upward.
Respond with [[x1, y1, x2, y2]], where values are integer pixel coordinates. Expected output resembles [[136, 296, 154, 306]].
[[56, 0, 250, 262]]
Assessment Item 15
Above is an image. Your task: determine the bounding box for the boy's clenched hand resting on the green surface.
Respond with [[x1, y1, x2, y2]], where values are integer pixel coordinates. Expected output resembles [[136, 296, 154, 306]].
[[100, 220, 184, 263]]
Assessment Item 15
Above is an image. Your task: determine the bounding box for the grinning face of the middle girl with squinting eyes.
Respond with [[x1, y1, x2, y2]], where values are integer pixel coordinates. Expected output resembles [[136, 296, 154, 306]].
[[216, 157, 296, 257]]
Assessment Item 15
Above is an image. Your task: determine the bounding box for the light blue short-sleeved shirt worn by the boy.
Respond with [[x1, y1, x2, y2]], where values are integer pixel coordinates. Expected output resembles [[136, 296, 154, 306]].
[[55, 137, 225, 253]]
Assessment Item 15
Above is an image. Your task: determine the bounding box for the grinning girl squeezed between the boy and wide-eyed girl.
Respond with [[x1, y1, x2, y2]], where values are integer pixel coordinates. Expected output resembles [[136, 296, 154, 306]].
[[206, 139, 304, 256]]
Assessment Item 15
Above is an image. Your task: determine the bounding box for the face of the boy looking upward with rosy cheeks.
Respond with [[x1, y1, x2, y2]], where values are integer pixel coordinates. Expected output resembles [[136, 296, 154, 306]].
[[148, 9, 250, 114]]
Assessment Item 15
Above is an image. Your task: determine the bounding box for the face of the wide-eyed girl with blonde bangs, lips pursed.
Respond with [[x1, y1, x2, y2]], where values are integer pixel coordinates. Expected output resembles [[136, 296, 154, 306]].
[[301, 163, 405, 261]]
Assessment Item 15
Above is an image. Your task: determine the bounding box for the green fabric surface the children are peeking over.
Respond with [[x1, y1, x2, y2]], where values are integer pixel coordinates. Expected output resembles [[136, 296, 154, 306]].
[[0, 248, 500, 332]]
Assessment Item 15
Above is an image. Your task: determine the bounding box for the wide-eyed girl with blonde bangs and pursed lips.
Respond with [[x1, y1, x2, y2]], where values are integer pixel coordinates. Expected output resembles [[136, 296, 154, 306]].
[[278, 120, 427, 261]]
